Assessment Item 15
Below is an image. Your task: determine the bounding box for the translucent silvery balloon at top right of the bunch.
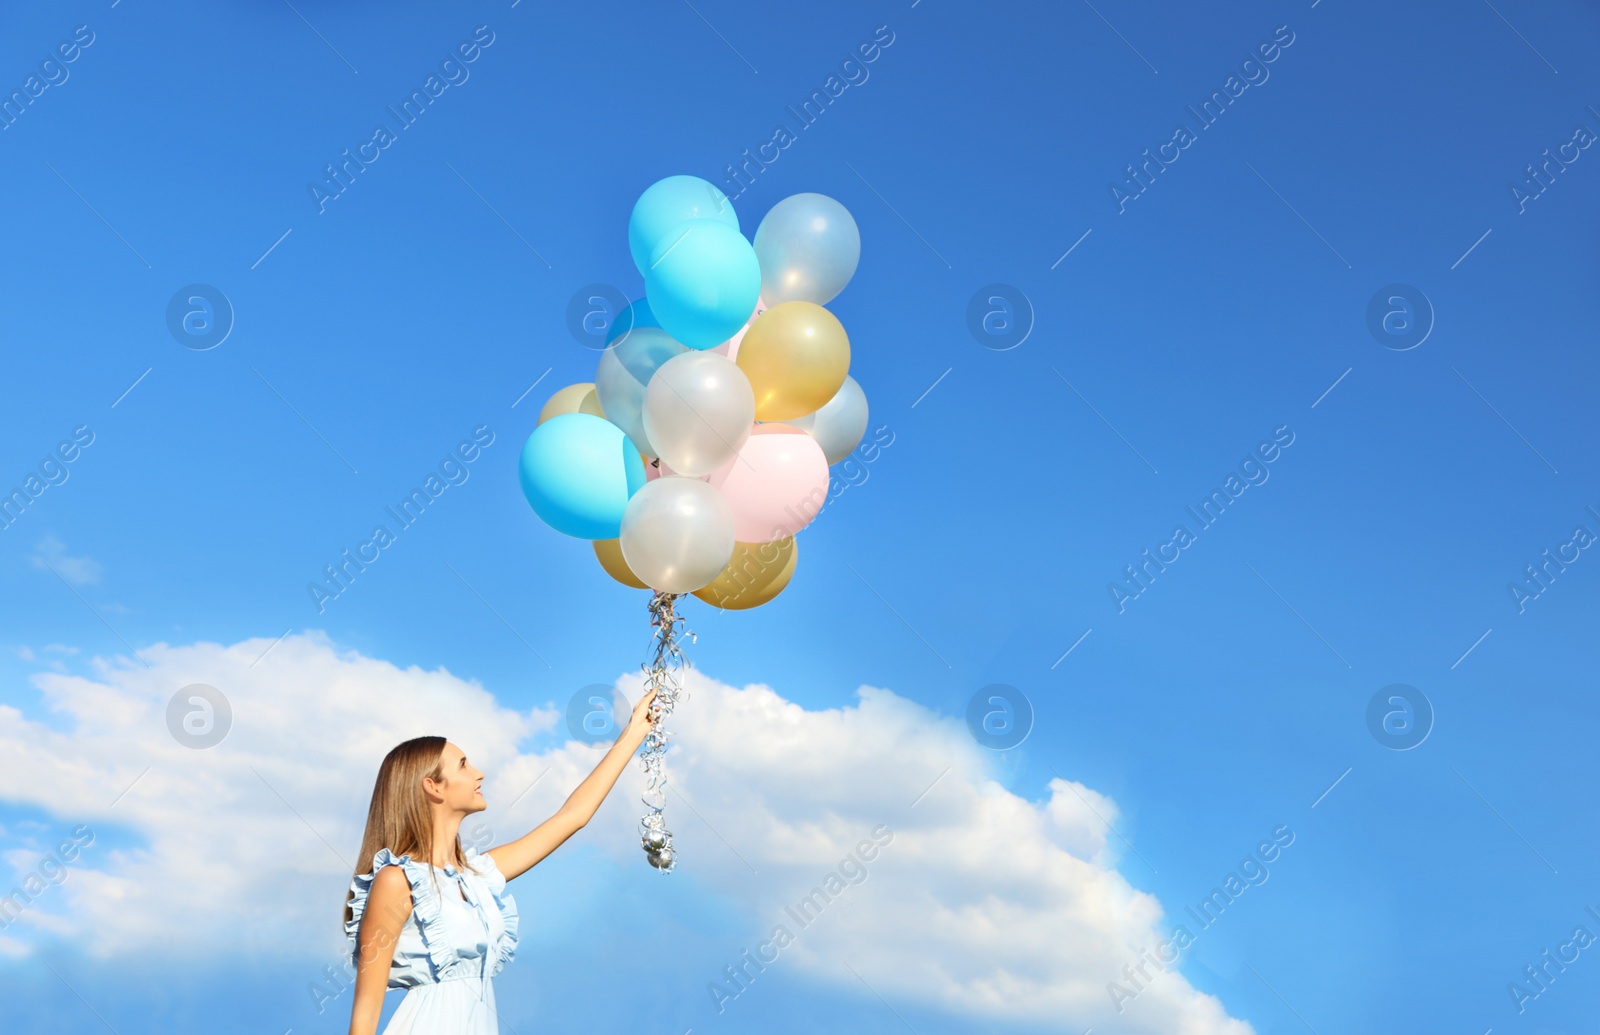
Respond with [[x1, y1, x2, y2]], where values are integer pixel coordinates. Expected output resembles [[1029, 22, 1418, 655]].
[[752, 194, 861, 305]]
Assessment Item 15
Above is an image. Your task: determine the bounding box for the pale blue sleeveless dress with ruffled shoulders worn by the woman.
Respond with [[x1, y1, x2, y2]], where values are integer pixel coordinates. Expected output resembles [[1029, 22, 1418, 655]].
[[344, 848, 517, 1035]]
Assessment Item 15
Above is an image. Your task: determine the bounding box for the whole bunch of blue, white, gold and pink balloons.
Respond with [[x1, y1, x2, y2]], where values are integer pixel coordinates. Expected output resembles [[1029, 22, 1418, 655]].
[[520, 176, 867, 609]]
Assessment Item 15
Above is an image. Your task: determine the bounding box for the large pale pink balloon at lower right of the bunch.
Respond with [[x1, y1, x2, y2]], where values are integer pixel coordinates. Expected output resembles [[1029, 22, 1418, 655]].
[[706, 424, 827, 542]]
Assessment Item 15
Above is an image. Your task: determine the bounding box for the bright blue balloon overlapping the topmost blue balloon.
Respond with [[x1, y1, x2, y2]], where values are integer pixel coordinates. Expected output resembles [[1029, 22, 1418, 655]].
[[645, 219, 762, 349]]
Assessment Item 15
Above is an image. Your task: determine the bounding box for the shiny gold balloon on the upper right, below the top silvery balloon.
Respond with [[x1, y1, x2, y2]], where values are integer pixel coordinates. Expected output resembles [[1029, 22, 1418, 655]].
[[736, 302, 850, 421]]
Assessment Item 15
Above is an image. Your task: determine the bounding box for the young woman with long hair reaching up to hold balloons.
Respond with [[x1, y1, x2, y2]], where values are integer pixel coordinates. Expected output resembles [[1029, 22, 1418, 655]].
[[344, 691, 656, 1035]]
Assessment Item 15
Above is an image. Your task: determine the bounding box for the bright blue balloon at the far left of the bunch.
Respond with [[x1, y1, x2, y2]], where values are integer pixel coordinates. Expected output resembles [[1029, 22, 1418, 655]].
[[517, 413, 645, 539]]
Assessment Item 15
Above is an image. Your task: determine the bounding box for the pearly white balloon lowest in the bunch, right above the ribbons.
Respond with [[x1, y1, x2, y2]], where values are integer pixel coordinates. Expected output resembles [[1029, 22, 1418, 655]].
[[619, 475, 733, 593]]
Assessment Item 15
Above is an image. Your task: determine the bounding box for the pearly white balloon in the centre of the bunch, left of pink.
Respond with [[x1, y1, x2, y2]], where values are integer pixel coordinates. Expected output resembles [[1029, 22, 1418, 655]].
[[643, 352, 755, 478]]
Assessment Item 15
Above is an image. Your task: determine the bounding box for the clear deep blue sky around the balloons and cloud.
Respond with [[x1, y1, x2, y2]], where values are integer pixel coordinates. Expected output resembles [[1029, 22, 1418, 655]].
[[0, 0, 1600, 1035]]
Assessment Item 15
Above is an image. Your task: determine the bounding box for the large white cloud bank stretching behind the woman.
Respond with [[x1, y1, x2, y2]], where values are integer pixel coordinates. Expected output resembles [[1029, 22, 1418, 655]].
[[0, 633, 1251, 1035]]
